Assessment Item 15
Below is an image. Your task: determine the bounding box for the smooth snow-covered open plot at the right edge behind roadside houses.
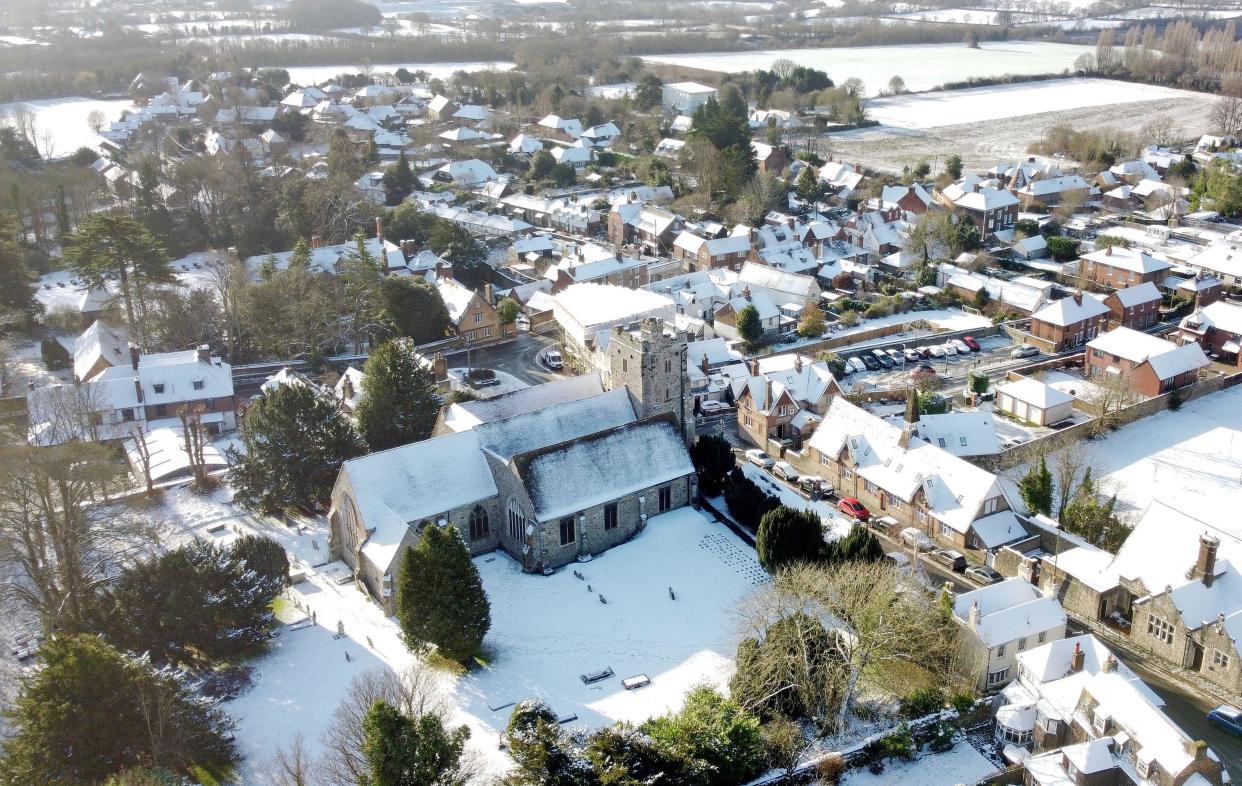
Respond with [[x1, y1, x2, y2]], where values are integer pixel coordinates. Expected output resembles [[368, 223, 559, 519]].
[[1048, 387, 1242, 524]]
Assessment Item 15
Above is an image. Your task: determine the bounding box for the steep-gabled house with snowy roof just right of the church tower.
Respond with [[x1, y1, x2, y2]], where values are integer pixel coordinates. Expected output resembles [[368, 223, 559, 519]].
[[725, 353, 841, 449]]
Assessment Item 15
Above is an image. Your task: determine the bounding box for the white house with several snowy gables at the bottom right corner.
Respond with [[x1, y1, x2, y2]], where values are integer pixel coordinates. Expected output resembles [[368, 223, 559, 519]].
[[995, 635, 1228, 786]]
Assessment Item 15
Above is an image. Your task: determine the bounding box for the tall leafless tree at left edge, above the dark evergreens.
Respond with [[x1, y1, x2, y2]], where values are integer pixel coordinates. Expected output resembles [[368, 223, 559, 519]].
[[0, 442, 160, 636]]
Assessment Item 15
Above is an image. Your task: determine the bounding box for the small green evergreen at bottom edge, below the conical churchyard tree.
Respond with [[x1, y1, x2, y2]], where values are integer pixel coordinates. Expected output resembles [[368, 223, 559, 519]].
[[360, 699, 469, 786]]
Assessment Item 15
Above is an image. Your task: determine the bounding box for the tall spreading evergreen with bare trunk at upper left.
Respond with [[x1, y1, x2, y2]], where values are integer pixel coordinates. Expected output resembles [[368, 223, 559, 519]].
[[65, 214, 176, 341]]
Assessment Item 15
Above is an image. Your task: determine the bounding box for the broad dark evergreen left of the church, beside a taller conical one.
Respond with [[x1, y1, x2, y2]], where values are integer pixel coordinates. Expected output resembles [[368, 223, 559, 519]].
[[229, 385, 365, 513]]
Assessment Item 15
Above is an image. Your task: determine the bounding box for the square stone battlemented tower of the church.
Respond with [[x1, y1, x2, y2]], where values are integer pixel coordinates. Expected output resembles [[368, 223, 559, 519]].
[[609, 319, 694, 445]]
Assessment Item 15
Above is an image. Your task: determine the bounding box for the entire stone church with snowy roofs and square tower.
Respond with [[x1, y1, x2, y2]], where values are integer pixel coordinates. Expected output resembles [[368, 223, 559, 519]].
[[328, 320, 697, 613]]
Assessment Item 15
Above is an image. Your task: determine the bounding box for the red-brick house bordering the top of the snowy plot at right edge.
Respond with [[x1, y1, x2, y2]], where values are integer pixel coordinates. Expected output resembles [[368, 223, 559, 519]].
[[1083, 328, 1208, 397]]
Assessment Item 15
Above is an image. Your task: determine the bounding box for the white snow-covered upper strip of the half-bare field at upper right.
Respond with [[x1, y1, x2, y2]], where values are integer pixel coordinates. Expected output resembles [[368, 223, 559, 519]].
[[867, 78, 1190, 129]]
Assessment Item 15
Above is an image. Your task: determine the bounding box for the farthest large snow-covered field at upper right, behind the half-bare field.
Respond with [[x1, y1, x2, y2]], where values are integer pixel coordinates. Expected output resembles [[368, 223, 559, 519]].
[[643, 41, 1095, 94]]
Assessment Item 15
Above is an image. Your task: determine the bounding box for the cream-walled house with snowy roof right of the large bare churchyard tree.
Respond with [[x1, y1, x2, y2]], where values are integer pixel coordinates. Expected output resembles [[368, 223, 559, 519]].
[[953, 577, 1066, 693]]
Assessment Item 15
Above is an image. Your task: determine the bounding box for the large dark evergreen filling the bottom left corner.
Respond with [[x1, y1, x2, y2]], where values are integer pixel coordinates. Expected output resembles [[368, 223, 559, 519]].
[[0, 636, 238, 786]]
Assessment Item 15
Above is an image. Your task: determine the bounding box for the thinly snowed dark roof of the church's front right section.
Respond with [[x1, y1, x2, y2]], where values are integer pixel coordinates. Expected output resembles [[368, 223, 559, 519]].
[[518, 420, 694, 522]]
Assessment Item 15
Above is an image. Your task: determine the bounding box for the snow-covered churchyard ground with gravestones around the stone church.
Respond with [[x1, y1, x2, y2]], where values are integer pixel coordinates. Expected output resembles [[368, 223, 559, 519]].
[[175, 488, 768, 785]]
